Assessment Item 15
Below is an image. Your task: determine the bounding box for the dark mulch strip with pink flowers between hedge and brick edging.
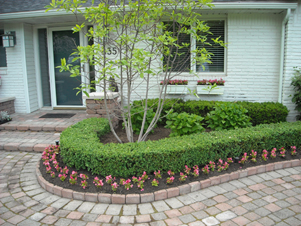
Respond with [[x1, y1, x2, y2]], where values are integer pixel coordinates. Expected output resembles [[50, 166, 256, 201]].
[[40, 144, 301, 194]]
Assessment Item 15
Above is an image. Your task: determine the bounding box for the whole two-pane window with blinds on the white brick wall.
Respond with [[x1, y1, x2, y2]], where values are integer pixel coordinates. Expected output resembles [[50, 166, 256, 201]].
[[163, 20, 225, 73]]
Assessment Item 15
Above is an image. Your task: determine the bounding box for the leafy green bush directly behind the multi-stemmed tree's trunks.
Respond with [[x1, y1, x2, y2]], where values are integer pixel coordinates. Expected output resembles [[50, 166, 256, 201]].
[[122, 106, 157, 134]]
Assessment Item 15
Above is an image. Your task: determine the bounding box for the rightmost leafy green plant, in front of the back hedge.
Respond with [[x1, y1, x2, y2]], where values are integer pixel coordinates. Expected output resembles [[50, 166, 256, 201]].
[[206, 102, 252, 130]]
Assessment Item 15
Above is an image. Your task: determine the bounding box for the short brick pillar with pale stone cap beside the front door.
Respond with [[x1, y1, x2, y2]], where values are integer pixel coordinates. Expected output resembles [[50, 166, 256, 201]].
[[84, 92, 120, 128]]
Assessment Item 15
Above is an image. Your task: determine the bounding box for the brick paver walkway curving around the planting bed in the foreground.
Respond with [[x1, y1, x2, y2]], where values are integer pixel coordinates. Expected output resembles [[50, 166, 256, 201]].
[[0, 151, 301, 226]]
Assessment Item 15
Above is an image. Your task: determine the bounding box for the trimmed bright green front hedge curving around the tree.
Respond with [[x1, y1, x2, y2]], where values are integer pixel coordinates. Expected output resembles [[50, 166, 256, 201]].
[[60, 118, 301, 177]]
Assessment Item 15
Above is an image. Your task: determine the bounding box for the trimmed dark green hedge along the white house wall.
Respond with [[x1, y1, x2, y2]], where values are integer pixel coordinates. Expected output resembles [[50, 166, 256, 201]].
[[134, 99, 289, 126]]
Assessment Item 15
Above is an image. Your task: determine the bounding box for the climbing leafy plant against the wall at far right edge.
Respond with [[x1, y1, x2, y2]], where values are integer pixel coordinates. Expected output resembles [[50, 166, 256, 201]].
[[291, 67, 301, 120]]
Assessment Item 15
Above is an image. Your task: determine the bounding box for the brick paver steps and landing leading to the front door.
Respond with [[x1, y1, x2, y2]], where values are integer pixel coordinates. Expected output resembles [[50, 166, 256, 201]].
[[0, 110, 87, 152]]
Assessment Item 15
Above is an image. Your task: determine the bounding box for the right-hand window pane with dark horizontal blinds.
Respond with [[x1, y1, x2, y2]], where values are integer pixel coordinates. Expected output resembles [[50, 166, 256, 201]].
[[196, 20, 225, 72]]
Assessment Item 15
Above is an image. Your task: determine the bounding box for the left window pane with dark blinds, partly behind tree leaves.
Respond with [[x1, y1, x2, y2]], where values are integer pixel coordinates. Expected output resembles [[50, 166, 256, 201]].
[[163, 22, 190, 72]]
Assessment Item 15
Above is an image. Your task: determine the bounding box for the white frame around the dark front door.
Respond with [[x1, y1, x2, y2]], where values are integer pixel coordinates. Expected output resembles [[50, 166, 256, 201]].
[[47, 26, 86, 108]]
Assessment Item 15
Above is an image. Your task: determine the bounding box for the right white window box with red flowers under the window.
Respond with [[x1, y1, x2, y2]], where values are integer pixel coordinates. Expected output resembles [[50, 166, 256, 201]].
[[196, 79, 225, 94]]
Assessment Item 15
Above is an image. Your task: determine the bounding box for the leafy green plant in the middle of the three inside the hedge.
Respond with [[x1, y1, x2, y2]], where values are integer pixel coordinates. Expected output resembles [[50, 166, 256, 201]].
[[165, 111, 205, 137]]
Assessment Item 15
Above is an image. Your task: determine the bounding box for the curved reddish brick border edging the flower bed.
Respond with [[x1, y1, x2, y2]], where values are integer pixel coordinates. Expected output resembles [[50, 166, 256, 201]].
[[36, 159, 301, 204]]
